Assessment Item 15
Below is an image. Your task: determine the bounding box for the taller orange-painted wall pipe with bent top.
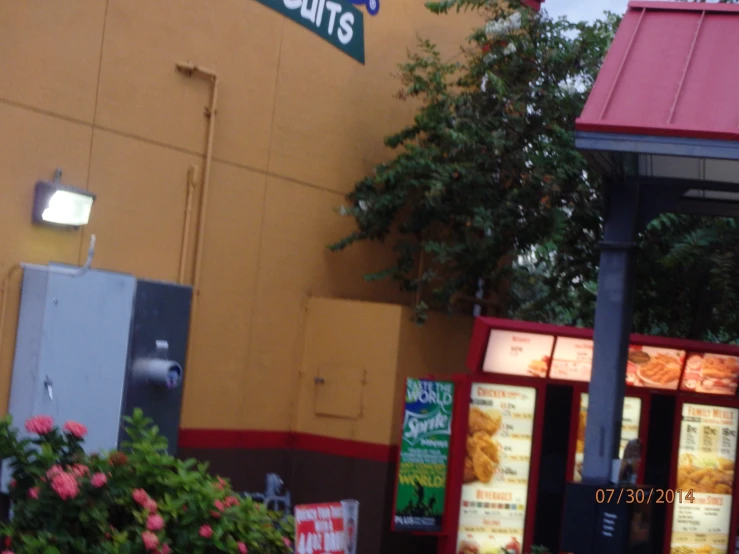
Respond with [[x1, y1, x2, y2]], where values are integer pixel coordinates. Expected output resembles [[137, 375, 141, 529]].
[[175, 62, 218, 376]]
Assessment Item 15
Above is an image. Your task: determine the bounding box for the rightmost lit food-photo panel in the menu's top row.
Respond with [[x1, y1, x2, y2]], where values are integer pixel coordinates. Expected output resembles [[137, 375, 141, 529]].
[[680, 354, 739, 396]]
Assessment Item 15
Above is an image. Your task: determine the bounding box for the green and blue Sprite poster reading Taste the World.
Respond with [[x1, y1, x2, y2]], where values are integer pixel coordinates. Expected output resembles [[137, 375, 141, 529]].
[[394, 379, 454, 533]]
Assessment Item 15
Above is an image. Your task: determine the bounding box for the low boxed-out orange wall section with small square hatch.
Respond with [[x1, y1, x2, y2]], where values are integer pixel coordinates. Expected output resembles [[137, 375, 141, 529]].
[[294, 298, 472, 445]]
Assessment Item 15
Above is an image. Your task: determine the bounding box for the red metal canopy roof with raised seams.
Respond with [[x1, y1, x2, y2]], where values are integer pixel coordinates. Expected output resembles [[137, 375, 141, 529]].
[[576, 1, 739, 140]]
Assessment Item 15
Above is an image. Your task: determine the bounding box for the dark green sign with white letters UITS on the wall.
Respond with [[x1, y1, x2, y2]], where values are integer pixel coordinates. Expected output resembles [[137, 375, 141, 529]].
[[257, 0, 364, 64]]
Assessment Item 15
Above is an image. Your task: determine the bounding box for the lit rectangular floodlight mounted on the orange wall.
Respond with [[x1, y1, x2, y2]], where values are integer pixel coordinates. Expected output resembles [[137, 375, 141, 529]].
[[33, 170, 95, 228]]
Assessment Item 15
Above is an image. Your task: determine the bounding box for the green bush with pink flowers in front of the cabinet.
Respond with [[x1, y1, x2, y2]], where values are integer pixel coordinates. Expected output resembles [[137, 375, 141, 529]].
[[0, 410, 293, 554]]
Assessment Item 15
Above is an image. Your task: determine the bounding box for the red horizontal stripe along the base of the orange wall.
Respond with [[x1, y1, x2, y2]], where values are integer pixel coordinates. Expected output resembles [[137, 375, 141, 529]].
[[178, 429, 397, 462]]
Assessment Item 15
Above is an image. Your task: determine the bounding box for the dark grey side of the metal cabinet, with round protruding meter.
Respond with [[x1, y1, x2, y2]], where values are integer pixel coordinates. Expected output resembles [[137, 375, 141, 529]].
[[120, 280, 192, 454]]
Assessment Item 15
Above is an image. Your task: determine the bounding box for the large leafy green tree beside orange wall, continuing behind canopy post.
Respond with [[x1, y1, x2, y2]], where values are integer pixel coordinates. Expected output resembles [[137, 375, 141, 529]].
[[331, 0, 739, 341]]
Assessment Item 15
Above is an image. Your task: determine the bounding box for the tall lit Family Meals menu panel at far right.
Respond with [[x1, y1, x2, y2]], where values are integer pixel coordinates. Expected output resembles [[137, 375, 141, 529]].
[[671, 404, 739, 554]]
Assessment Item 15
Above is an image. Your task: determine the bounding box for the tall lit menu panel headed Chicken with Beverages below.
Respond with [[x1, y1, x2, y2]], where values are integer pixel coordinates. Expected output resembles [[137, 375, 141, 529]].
[[457, 383, 536, 554]]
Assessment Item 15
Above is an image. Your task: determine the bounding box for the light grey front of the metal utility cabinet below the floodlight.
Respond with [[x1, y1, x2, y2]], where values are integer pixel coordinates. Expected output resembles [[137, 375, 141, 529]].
[[2, 266, 136, 490]]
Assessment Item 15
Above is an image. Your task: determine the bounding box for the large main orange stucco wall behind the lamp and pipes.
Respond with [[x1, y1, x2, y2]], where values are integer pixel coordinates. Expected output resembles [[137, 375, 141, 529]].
[[0, 0, 477, 432]]
